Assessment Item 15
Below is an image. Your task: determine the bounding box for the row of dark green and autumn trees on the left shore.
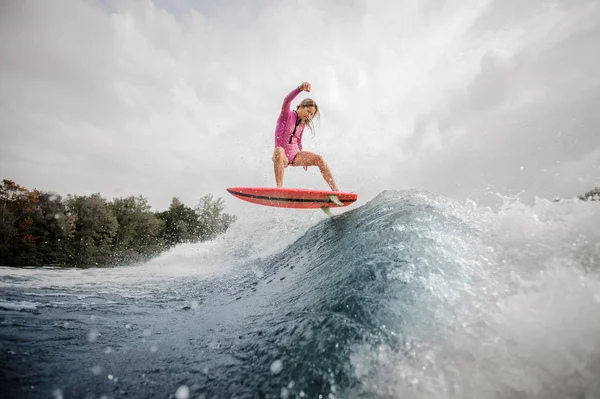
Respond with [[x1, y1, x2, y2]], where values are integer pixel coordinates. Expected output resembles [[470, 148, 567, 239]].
[[0, 180, 236, 266]]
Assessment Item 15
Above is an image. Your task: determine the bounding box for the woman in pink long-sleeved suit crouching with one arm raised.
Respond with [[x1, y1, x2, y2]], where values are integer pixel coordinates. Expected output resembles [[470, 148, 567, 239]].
[[273, 82, 339, 191]]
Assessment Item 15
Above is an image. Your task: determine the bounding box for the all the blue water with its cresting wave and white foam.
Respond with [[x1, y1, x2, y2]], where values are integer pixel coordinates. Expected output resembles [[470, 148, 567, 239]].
[[0, 191, 600, 399]]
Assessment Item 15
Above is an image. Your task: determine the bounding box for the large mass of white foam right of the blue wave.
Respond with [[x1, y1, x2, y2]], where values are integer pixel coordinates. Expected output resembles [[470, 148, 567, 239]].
[[352, 199, 600, 398]]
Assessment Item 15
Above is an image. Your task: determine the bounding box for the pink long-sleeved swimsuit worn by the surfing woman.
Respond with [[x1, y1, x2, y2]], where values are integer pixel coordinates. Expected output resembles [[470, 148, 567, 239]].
[[275, 87, 304, 165]]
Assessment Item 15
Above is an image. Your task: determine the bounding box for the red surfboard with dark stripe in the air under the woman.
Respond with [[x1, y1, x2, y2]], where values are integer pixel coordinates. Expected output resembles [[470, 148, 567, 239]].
[[227, 187, 358, 210]]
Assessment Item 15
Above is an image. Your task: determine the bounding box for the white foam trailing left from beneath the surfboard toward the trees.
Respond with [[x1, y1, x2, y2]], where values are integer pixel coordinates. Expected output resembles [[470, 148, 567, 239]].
[[0, 208, 326, 300]]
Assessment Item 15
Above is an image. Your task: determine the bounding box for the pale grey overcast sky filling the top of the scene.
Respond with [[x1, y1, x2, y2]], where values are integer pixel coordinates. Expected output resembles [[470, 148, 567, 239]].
[[0, 0, 600, 213]]
